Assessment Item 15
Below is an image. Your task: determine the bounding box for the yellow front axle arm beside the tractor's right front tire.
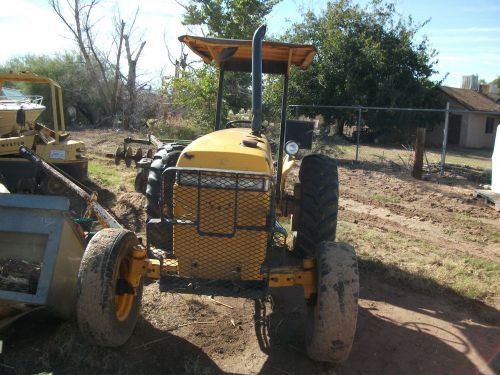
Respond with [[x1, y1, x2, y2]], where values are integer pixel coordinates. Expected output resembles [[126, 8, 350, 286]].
[[268, 259, 317, 299]]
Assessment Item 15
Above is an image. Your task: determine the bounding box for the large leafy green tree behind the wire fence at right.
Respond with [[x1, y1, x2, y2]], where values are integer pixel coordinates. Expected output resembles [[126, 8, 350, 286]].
[[276, 0, 444, 136]]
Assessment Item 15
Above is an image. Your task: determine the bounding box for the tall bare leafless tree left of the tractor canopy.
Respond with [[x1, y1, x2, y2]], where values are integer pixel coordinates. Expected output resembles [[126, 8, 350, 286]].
[[49, 0, 146, 129]]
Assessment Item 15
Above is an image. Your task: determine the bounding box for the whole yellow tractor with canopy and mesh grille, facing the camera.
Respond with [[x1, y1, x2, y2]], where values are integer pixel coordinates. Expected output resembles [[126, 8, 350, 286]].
[[58, 26, 359, 362]]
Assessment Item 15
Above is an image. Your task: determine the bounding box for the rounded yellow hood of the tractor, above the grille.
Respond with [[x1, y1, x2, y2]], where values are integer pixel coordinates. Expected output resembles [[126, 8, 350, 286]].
[[177, 128, 273, 174]]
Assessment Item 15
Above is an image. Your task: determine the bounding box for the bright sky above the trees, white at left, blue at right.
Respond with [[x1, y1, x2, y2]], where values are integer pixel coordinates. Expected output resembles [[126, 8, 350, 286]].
[[0, 0, 500, 87]]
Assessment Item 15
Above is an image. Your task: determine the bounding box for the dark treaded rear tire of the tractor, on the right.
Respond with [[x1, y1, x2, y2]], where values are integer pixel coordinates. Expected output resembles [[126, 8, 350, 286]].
[[295, 154, 339, 257]]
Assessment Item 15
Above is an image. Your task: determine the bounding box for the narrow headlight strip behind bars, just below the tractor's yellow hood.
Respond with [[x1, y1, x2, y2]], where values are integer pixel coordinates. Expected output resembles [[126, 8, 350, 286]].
[[178, 172, 269, 191]]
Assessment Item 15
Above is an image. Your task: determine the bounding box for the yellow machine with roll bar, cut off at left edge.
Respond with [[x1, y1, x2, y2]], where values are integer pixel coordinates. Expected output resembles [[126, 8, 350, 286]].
[[0, 72, 88, 195]]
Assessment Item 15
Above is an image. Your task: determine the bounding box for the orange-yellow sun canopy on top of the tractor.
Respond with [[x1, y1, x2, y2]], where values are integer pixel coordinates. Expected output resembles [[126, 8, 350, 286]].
[[179, 35, 316, 74]]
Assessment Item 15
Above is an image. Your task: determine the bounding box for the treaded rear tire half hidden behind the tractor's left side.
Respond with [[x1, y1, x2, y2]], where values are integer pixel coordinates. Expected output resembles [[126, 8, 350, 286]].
[[146, 145, 181, 251]]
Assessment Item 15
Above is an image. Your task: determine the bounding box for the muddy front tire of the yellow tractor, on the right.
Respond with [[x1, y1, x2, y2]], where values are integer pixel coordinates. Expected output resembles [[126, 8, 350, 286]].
[[306, 242, 359, 363]]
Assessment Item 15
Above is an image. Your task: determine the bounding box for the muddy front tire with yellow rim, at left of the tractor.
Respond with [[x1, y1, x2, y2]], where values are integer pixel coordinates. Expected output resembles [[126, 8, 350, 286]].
[[76, 228, 142, 347]]
